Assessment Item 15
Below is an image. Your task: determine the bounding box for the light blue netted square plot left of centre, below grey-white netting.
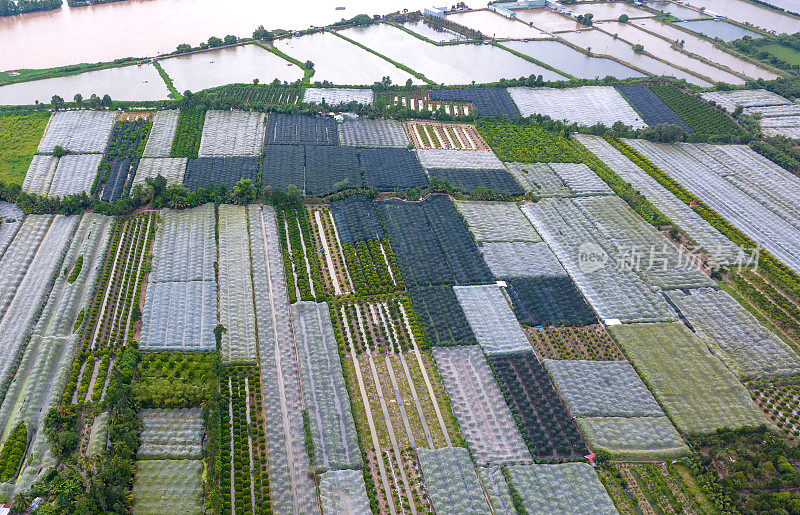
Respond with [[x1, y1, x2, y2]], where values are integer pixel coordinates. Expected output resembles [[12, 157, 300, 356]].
[[139, 281, 217, 351]]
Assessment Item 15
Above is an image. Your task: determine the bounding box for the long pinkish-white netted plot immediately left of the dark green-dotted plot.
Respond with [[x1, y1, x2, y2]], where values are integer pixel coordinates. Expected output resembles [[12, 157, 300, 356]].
[[432, 345, 533, 466]]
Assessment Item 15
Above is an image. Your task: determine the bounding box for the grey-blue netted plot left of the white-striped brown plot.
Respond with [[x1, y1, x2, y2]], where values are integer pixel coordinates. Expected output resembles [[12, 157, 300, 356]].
[[265, 113, 339, 145]]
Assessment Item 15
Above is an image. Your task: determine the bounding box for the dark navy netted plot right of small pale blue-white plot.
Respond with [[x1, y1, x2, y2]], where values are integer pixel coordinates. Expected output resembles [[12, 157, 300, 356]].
[[506, 278, 597, 326]]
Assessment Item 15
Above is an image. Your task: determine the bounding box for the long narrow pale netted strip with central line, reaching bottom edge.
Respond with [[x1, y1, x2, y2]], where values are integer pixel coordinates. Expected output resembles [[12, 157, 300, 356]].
[[247, 205, 317, 513]]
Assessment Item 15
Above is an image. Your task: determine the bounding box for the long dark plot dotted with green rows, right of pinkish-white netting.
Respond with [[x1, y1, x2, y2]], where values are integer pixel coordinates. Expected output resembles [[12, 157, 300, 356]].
[[488, 352, 587, 460]]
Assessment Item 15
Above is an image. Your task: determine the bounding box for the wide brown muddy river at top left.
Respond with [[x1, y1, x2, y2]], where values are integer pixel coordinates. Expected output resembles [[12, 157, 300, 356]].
[[0, 0, 438, 70]]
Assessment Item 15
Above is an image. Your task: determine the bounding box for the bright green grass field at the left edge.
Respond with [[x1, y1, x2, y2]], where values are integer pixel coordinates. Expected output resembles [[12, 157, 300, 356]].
[[0, 111, 50, 185]]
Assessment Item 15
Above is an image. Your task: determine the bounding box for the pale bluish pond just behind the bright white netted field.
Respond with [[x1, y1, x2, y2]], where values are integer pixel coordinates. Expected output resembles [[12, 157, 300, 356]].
[[503, 41, 644, 79]]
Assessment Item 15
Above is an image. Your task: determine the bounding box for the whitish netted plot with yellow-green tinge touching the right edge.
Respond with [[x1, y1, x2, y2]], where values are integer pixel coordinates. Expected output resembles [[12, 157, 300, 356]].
[[667, 288, 800, 381]]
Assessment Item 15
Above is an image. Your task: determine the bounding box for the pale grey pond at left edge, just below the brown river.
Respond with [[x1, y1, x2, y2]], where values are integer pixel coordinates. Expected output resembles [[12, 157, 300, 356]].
[[0, 64, 169, 105]]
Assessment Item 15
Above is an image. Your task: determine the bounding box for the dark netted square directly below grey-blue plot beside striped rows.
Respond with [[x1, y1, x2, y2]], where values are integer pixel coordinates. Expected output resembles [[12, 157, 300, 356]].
[[359, 148, 428, 191]]
